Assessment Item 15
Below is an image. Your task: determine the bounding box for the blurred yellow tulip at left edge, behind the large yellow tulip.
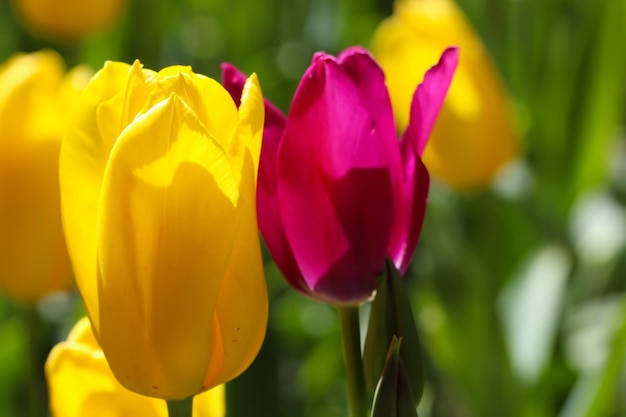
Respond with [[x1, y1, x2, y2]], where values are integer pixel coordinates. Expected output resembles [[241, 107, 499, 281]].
[[0, 51, 91, 302]]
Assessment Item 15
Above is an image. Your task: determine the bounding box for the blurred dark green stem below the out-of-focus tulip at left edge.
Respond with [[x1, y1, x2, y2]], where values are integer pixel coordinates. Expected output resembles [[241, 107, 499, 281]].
[[22, 306, 48, 417]]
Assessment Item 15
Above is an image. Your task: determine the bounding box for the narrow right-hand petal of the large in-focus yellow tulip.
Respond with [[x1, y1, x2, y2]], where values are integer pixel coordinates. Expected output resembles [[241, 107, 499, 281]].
[[204, 74, 268, 386]]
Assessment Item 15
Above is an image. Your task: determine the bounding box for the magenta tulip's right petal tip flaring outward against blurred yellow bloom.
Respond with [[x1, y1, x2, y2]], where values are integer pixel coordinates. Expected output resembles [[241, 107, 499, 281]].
[[405, 48, 459, 156]]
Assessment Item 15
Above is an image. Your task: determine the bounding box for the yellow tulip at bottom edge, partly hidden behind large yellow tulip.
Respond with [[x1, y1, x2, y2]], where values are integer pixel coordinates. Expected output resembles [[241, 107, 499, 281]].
[[45, 317, 226, 417]]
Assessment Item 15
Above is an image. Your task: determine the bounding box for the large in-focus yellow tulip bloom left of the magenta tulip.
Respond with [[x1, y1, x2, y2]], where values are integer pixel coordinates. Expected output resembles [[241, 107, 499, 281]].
[[60, 61, 267, 399]]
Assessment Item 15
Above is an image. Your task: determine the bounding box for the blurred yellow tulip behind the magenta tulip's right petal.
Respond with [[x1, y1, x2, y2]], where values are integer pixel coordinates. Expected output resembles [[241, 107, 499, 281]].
[[372, 0, 519, 188]]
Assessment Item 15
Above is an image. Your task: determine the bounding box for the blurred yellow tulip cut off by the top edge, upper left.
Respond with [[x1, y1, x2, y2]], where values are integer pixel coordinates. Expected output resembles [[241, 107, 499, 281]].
[[13, 0, 126, 41]]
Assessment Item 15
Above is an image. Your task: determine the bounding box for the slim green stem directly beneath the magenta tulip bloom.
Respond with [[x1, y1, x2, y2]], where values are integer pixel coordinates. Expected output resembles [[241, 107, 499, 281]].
[[337, 306, 367, 417]]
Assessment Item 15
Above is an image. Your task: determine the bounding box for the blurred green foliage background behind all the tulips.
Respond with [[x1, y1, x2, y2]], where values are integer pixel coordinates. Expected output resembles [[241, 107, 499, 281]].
[[0, 0, 626, 417]]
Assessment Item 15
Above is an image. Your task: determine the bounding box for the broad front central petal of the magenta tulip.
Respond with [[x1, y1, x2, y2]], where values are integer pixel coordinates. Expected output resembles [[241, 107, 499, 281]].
[[278, 54, 399, 303]]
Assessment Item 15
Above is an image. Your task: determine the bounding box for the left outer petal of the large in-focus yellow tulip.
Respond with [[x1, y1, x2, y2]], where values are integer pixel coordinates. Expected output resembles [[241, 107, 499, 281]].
[[59, 62, 129, 328]]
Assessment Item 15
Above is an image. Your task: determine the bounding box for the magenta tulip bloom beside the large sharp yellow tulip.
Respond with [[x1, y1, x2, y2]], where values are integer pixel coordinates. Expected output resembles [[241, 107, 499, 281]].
[[223, 47, 457, 305]]
